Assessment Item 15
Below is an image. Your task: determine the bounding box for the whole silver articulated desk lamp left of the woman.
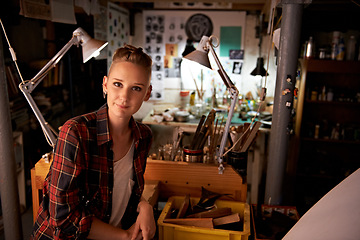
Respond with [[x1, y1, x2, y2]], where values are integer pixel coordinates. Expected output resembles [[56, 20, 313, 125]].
[[3, 23, 108, 147]]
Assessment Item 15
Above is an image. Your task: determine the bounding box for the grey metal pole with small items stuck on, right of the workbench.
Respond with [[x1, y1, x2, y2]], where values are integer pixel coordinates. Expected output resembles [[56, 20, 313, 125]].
[[264, 0, 303, 205]]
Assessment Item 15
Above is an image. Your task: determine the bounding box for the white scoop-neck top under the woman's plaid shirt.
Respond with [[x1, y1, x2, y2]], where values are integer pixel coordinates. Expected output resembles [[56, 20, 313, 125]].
[[110, 142, 135, 227]]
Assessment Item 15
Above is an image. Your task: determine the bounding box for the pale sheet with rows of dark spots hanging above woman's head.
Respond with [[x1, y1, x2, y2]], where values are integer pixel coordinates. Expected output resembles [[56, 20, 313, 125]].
[[107, 2, 130, 69]]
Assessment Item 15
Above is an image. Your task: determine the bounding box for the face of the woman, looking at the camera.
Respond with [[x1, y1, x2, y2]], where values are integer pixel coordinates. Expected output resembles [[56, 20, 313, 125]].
[[103, 62, 151, 121]]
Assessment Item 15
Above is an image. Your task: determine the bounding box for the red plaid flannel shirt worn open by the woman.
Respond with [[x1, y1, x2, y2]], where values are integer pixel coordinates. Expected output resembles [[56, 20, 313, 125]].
[[31, 104, 152, 239]]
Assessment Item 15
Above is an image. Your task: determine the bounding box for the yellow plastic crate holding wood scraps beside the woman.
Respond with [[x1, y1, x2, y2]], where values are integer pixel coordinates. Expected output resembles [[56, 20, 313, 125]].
[[158, 196, 250, 240]]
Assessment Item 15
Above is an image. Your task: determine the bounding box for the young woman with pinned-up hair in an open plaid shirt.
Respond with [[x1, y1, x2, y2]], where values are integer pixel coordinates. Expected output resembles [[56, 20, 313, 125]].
[[31, 45, 156, 239]]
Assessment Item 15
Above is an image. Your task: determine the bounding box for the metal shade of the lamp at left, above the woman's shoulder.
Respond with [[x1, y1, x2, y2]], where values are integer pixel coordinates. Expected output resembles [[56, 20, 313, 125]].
[[73, 28, 108, 63]]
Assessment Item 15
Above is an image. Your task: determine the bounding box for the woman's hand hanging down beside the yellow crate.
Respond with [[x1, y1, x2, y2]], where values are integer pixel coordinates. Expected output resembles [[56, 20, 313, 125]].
[[131, 201, 156, 240]]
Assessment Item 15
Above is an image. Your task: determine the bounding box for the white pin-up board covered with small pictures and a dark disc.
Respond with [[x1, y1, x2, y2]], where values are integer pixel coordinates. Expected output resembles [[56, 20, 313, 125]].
[[143, 10, 246, 100]]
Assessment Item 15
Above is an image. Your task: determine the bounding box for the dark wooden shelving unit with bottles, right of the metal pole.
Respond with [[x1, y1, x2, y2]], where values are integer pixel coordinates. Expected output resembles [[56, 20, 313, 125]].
[[293, 59, 360, 213]]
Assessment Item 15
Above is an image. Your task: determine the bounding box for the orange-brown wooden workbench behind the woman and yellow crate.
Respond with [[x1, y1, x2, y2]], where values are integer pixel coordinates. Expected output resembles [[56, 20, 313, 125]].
[[31, 158, 247, 221]]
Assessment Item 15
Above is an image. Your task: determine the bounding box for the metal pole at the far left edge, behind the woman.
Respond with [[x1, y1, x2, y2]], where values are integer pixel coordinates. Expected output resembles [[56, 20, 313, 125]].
[[0, 32, 23, 240]]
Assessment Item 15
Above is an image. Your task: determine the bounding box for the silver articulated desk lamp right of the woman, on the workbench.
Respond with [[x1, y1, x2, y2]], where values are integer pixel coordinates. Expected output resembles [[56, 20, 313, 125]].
[[184, 36, 239, 174]]
